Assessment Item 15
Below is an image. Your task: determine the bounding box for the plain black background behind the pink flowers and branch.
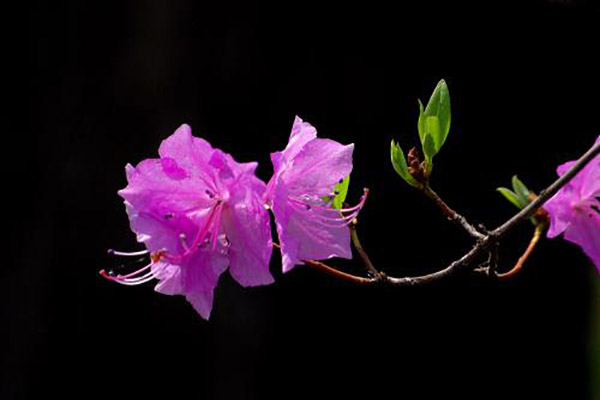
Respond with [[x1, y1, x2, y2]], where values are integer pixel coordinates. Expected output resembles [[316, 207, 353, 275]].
[[10, 1, 600, 399]]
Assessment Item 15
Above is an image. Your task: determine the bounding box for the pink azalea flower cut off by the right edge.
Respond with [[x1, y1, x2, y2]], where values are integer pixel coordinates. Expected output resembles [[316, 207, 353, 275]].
[[544, 136, 600, 272]]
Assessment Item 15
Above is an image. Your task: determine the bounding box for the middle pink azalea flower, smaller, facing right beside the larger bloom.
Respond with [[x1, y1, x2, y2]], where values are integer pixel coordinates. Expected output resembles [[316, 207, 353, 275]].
[[265, 117, 365, 272]]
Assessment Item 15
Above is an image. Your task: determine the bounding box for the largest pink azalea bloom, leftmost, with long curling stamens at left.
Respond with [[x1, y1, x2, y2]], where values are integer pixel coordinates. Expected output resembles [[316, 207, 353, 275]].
[[102, 125, 273, 319]]
